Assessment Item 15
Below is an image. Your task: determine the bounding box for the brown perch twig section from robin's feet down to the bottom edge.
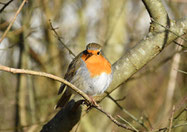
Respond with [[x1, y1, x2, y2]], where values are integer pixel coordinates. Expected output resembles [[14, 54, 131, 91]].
[[93, 105, 136, 132]]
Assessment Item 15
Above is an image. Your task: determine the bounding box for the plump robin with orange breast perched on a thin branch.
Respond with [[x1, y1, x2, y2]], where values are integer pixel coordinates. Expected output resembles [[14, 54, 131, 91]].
[[56, 43, 112, 108]]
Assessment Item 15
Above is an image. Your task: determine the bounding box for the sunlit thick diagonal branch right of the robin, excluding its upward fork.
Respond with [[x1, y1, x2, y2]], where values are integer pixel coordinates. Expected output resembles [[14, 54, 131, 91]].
[[98, 0, 187, 100]]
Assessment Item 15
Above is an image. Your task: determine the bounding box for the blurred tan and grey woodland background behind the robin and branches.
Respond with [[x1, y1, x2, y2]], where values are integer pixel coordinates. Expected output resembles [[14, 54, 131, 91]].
[[0, 0, 187, 132]]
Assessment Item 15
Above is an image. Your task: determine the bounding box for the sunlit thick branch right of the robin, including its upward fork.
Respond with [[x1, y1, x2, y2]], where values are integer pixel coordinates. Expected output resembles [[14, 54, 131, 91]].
[[38, 0, 187, 131]]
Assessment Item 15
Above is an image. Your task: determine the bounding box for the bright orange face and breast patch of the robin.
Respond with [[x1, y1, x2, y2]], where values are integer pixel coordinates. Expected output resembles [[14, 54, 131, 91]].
[[81, 54, 112, 77]]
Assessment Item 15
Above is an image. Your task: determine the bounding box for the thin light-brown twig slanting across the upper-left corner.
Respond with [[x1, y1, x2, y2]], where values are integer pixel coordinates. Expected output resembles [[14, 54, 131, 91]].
[[0, 0, 27, 44]]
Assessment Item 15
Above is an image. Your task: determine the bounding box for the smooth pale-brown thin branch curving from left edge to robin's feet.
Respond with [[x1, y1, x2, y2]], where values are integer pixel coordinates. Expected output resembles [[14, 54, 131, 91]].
[[0, 65, 91, 103]]
